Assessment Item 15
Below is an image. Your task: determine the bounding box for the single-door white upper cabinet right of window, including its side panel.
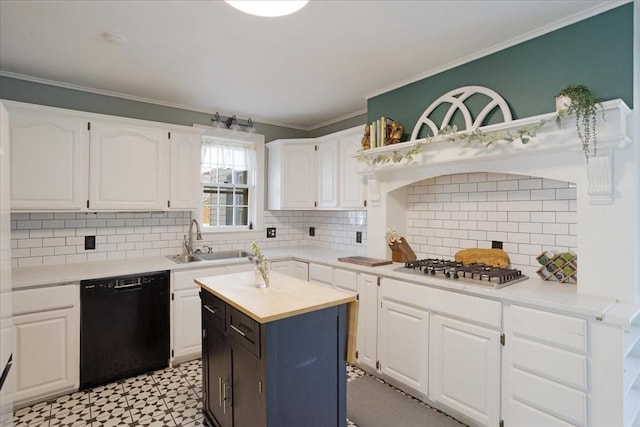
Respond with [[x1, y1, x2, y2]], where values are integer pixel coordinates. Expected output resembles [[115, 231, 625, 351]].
[[267, 138, 318, 210]]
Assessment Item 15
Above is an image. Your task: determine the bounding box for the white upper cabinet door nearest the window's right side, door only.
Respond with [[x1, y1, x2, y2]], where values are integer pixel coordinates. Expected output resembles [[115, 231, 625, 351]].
[[282, 144, 318, 209]]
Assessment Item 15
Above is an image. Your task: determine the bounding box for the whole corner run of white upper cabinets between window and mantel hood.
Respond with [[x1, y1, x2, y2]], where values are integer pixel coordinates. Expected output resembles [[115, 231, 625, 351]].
[[267, 126, 365, 210]]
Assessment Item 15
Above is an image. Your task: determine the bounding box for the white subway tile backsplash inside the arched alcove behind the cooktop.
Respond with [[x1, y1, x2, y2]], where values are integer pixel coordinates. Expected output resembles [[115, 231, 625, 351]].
[[406, 173, 577, 268]]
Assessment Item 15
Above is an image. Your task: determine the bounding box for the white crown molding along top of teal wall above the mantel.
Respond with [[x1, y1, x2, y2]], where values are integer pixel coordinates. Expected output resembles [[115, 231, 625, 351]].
[[364, 0, 633, 100]]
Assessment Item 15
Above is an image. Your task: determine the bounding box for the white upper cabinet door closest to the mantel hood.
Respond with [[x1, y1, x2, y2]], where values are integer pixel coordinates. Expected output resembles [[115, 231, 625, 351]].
[[339, 128, 365, 209]]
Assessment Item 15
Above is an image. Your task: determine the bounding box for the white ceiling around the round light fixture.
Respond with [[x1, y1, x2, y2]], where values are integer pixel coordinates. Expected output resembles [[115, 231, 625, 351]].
[[0, 0, 620, 130]]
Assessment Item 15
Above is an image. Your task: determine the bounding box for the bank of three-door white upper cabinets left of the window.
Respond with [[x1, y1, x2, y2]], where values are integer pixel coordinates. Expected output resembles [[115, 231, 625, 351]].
[[3, 101, 201, 212]]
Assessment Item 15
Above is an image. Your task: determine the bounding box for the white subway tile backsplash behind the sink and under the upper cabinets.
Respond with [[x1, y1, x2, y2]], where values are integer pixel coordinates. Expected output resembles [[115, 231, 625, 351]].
[[11, 211, 367, 267]]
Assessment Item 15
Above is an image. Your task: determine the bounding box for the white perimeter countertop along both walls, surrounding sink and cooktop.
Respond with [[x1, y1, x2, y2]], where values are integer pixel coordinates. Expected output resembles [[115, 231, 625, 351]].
[[13, 247, 640, 326]]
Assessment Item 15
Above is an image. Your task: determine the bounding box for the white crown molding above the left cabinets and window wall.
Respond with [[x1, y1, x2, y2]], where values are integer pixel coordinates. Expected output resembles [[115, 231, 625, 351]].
[[0, 70, 315, 131]]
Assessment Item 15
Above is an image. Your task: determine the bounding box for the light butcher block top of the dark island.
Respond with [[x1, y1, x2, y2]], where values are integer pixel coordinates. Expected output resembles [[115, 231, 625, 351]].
[[195, 272, 356, 323]]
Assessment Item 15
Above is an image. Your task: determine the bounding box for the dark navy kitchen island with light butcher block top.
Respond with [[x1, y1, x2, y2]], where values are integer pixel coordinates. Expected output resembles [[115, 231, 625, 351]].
[[195, 272, 355, 427]]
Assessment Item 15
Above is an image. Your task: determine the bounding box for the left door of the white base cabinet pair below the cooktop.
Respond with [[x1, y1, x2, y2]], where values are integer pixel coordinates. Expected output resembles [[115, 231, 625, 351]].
[[378, 300, 429, 397]]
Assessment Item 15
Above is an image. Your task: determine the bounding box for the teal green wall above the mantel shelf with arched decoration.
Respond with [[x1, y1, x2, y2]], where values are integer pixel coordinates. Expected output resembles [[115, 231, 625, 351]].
[[367, 3, 633, 140]]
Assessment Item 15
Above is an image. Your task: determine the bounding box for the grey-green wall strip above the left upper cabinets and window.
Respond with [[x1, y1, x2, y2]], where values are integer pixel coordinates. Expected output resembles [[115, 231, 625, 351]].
[[0, 76, 312, 142]]
